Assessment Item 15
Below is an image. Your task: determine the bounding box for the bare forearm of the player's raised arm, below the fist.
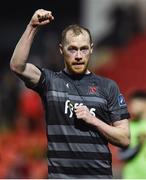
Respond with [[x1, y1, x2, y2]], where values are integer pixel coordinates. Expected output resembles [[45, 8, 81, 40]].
[[10, 24, 37, 72]]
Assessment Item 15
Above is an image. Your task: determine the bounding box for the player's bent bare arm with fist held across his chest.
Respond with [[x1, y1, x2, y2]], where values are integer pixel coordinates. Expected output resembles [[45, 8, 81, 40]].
[[75, 106, 130, 147]]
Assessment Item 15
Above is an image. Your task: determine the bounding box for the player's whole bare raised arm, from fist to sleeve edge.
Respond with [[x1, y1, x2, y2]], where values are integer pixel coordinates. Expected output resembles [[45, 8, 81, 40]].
[[10, 9, 54, 85]]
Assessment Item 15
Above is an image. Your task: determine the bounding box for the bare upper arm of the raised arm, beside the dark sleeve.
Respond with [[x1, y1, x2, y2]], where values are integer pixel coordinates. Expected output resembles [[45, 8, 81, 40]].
[[17, 63, 41, 86]]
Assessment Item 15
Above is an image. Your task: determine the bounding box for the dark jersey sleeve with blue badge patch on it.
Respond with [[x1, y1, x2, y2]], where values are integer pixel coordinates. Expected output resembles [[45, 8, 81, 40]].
[[108, 81, 130, 122]]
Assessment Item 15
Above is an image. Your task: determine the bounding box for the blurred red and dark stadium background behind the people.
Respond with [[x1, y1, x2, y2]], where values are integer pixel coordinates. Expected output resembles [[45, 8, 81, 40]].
[[0, 0, 146, 178]]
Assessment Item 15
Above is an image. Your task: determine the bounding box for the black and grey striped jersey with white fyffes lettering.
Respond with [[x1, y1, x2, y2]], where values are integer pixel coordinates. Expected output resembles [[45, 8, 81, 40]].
[[27, 69, 129, 179]]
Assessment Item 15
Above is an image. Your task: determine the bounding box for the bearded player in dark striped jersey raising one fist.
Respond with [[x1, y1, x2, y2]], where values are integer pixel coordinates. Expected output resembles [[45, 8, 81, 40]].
[[10, 9, 130, 179]]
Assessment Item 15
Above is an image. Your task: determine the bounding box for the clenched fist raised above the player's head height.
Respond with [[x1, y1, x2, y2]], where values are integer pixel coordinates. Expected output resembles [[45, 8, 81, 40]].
[[30, 9, 54, 27]]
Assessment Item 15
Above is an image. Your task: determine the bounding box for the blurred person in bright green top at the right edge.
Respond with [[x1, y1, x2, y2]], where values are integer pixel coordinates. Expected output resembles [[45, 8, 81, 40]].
[[119, 90, 146, 179]]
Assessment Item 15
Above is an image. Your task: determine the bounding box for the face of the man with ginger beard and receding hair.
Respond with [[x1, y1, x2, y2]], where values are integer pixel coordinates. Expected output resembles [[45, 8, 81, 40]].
[[60, 31, 93, 74]]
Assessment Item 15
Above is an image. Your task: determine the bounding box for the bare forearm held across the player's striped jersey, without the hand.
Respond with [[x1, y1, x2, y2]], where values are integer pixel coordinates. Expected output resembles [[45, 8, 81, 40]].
[[92, 117, 130, 147]]
